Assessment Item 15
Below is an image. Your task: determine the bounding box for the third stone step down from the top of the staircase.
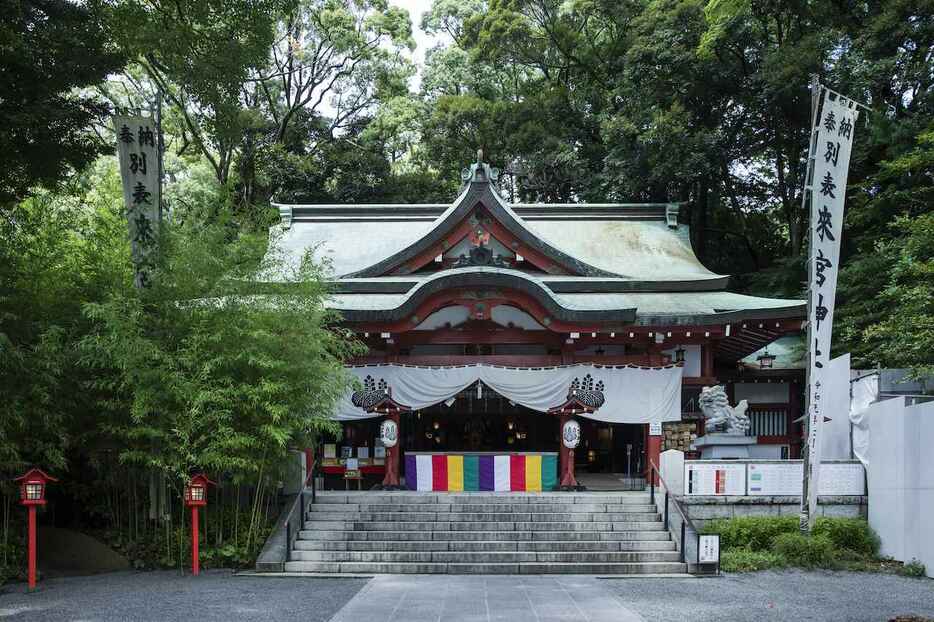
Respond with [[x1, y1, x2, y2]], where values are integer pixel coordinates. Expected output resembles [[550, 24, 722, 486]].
[[306, 506, 661, 523]]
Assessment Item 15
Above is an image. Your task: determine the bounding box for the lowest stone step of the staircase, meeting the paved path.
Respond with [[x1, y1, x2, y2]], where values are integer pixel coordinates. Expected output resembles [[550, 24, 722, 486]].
[[285, 561, 687, 575]]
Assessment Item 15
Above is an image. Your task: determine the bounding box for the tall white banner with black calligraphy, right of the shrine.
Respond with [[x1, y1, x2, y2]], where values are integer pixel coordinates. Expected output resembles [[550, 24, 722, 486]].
[[807, 90, 858, 517]]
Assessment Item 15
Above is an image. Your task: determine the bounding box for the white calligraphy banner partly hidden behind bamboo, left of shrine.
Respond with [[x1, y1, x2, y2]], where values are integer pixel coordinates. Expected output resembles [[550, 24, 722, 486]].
[[114, 116, 160, 287]]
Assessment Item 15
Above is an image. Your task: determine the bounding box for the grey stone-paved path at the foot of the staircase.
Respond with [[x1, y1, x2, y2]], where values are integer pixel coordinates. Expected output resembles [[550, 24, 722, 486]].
[[331, 575, 648, 622]]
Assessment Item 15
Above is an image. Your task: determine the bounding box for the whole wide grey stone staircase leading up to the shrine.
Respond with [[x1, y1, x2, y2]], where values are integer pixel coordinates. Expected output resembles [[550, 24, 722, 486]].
[[285, 492, 687, 575]]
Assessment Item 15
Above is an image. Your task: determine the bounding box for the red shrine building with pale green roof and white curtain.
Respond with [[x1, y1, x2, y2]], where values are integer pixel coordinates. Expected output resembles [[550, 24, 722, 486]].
[[272, 158, 806, 491]]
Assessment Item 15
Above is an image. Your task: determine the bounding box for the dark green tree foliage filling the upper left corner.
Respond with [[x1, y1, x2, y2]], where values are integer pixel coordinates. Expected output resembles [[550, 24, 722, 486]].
[[0, 0, 126, 208]]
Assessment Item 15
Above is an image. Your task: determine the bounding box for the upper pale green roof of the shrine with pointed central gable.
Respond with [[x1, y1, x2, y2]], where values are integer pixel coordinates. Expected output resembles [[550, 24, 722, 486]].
[[274, 173, 729, 290]]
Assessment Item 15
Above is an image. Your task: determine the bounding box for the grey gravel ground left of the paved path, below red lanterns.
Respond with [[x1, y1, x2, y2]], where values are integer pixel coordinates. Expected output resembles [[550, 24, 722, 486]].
[[0, 570, 367, 622]]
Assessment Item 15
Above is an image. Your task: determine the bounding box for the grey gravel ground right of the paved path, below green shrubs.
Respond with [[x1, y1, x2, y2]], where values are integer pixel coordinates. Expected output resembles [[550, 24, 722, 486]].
[[606, 571, 934, 622]]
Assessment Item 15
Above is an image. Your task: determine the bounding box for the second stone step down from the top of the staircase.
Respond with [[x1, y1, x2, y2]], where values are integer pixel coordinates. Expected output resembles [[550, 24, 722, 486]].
[[308, 503, 657, 514]]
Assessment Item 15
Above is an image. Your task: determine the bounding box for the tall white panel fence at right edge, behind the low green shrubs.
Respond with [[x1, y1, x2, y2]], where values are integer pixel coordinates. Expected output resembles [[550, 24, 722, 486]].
[[868, 397, 934, 577]]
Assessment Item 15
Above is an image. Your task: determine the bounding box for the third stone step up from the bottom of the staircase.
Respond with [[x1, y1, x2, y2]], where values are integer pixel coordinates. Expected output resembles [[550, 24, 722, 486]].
[[295, 540, 676, 553]]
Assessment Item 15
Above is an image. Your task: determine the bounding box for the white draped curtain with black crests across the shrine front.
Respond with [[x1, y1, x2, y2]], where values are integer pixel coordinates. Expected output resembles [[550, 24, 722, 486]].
[[334, 364, 682, 423]]
